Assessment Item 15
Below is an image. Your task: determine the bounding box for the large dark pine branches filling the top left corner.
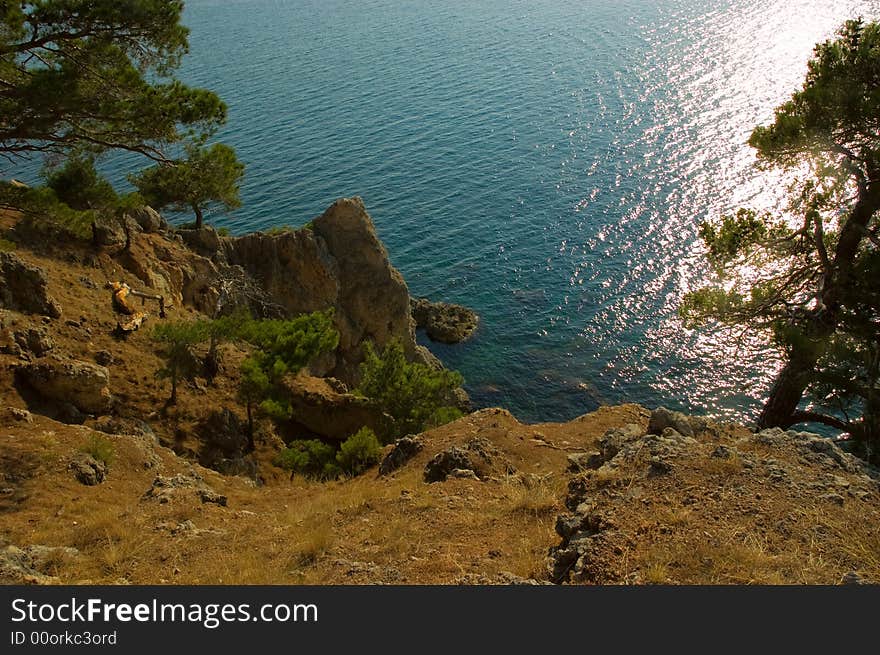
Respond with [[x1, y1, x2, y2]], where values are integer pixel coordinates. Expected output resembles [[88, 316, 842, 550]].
[[0, 0, 226, 161]]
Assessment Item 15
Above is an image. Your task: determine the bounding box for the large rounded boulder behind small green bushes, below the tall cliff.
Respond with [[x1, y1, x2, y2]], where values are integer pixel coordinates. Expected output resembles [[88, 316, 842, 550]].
[[284, 374, 391, 441]]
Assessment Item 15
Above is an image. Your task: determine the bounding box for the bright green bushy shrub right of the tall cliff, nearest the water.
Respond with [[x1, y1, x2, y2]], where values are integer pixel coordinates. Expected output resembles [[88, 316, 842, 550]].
[[356, 339, 462, 443]]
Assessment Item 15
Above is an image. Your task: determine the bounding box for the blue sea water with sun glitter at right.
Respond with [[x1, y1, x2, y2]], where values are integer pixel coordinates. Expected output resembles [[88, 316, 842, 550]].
[[8, 0, 880, 421]]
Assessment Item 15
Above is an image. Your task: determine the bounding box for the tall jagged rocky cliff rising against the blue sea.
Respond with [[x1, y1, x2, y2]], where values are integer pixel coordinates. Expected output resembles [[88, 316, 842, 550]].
[[99, 198, 422, 385]]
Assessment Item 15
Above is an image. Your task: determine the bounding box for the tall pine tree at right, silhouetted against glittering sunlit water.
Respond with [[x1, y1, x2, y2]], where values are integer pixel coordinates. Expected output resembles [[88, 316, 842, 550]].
[[682, 20, 880, 455]]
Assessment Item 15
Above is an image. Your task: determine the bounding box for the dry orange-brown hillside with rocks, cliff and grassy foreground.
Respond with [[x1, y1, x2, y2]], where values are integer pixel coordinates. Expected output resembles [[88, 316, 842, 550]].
[[0, 200, 880, 584]]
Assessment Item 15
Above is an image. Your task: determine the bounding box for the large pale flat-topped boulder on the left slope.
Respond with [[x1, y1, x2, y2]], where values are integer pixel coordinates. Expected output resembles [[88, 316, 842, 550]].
[[18, 359, 113, 414]]
